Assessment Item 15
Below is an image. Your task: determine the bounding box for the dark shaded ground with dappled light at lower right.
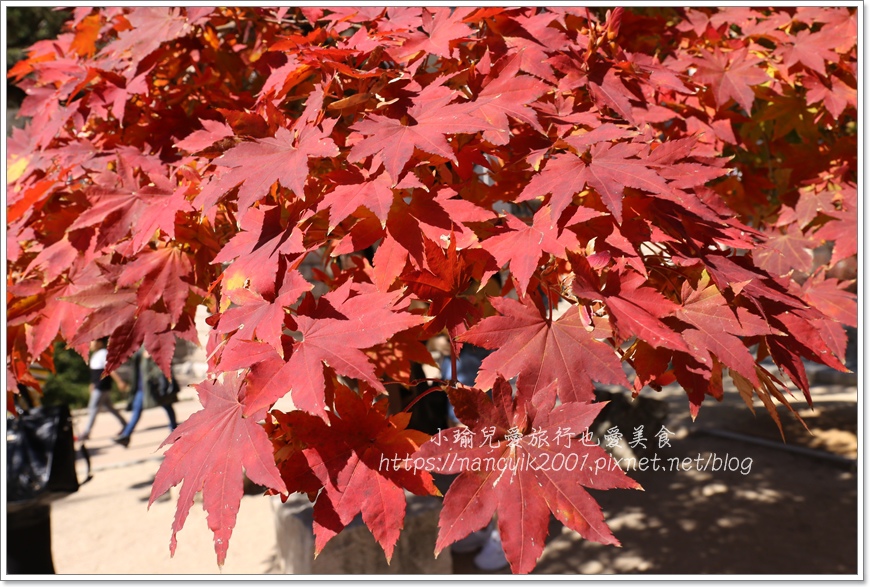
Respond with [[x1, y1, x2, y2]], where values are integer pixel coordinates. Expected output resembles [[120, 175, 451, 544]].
[[454, 387, 859, 575]]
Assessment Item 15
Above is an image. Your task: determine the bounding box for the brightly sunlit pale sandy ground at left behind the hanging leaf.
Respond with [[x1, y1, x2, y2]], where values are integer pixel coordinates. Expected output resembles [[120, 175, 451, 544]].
[[52, 388, 275, 575]]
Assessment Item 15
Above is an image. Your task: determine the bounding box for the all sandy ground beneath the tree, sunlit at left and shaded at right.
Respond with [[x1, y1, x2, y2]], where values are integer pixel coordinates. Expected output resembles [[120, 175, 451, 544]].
[[44, 374, 859, 578]]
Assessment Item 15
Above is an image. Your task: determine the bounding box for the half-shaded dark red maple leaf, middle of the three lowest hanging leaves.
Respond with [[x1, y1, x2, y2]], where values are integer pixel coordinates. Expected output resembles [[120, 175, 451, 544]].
[[273, 385, 440, 562]]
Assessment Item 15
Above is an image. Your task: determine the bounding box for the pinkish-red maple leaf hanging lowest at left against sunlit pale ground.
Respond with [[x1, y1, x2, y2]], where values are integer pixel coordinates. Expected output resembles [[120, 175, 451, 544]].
[[148, 373, 287, 565]]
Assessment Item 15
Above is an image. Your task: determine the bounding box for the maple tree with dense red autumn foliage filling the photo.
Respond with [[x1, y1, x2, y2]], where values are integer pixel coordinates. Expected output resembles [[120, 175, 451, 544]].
[[6, 7, 858, 572]]
